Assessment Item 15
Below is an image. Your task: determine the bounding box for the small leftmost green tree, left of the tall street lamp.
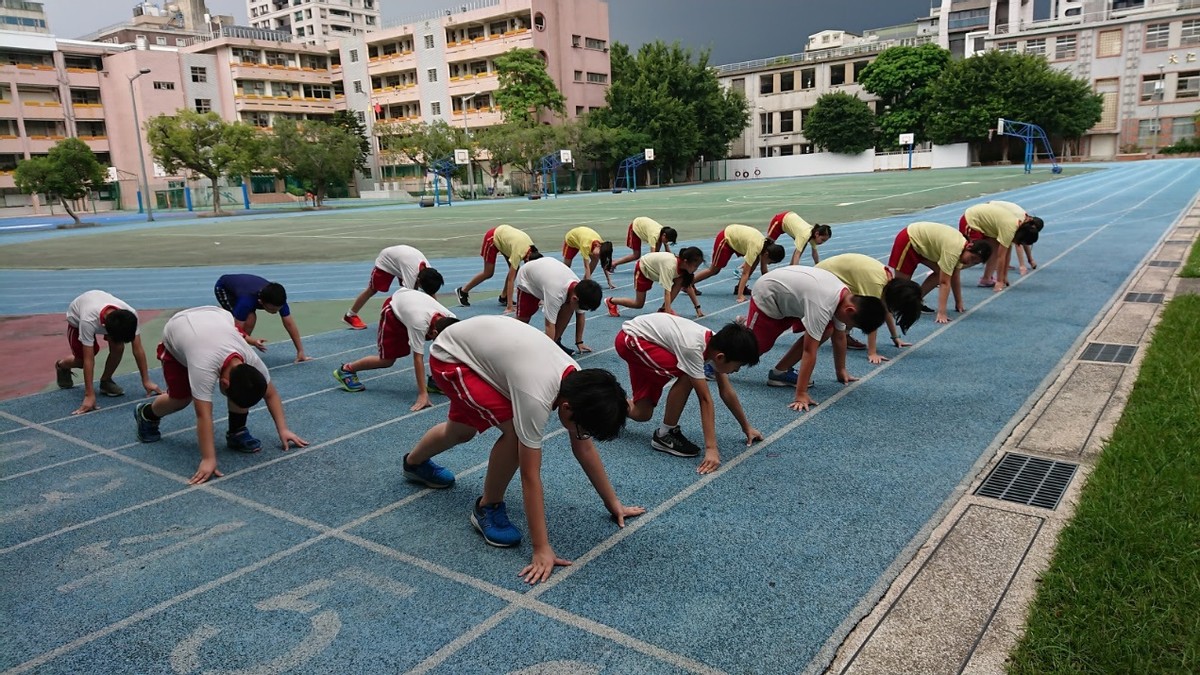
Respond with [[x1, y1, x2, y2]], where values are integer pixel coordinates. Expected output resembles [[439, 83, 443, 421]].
[[13, 138, 104, 225]]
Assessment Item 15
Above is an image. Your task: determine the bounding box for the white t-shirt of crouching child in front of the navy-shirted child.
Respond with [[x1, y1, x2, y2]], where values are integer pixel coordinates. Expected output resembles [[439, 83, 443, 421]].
[[162, 306, 271, 402]]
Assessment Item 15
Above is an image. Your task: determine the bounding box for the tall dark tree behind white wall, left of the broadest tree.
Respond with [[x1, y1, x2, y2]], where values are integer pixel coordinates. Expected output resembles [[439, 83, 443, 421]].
[[858, 42, 950, 148]]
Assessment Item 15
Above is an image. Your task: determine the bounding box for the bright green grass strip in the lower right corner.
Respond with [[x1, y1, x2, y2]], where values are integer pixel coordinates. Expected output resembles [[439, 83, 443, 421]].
[[1009, 294, 1200, 675]]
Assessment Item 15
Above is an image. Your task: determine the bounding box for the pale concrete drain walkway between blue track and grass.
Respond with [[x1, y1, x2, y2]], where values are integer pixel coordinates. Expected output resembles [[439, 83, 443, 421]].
[[827, 195, 1200, 675]]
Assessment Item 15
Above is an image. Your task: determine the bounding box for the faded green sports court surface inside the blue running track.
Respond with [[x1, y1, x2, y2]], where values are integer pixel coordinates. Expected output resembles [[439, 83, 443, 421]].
[[0, 167, 1093, 269]]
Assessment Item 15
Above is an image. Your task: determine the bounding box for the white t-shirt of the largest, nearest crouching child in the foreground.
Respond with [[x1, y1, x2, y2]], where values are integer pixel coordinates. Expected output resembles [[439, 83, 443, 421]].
[[430, 316, 580, 448]]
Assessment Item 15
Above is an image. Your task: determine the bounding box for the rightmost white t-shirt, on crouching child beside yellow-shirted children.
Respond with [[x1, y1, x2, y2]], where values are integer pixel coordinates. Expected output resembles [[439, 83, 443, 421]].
[[750, 265, 850, 338]]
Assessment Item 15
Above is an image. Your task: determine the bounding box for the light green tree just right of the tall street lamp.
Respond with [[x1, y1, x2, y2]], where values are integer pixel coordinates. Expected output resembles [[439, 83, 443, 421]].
[[146, 109, 259, 214]]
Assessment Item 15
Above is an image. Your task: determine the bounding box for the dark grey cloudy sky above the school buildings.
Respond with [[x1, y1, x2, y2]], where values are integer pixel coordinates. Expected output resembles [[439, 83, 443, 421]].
[[42, 0, 960, 64]]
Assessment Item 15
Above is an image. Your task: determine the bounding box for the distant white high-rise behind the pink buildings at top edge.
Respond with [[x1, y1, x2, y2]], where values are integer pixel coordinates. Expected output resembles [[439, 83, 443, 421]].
[[246, 0, 382, 43]]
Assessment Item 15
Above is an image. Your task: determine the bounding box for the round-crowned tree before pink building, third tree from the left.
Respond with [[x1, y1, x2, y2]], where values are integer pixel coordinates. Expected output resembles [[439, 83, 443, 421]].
[[266, 120, 361, 207]]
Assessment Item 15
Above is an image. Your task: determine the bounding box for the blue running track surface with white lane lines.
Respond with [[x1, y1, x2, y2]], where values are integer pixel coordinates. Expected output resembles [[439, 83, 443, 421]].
[[7, 160, 1200, 674]]
